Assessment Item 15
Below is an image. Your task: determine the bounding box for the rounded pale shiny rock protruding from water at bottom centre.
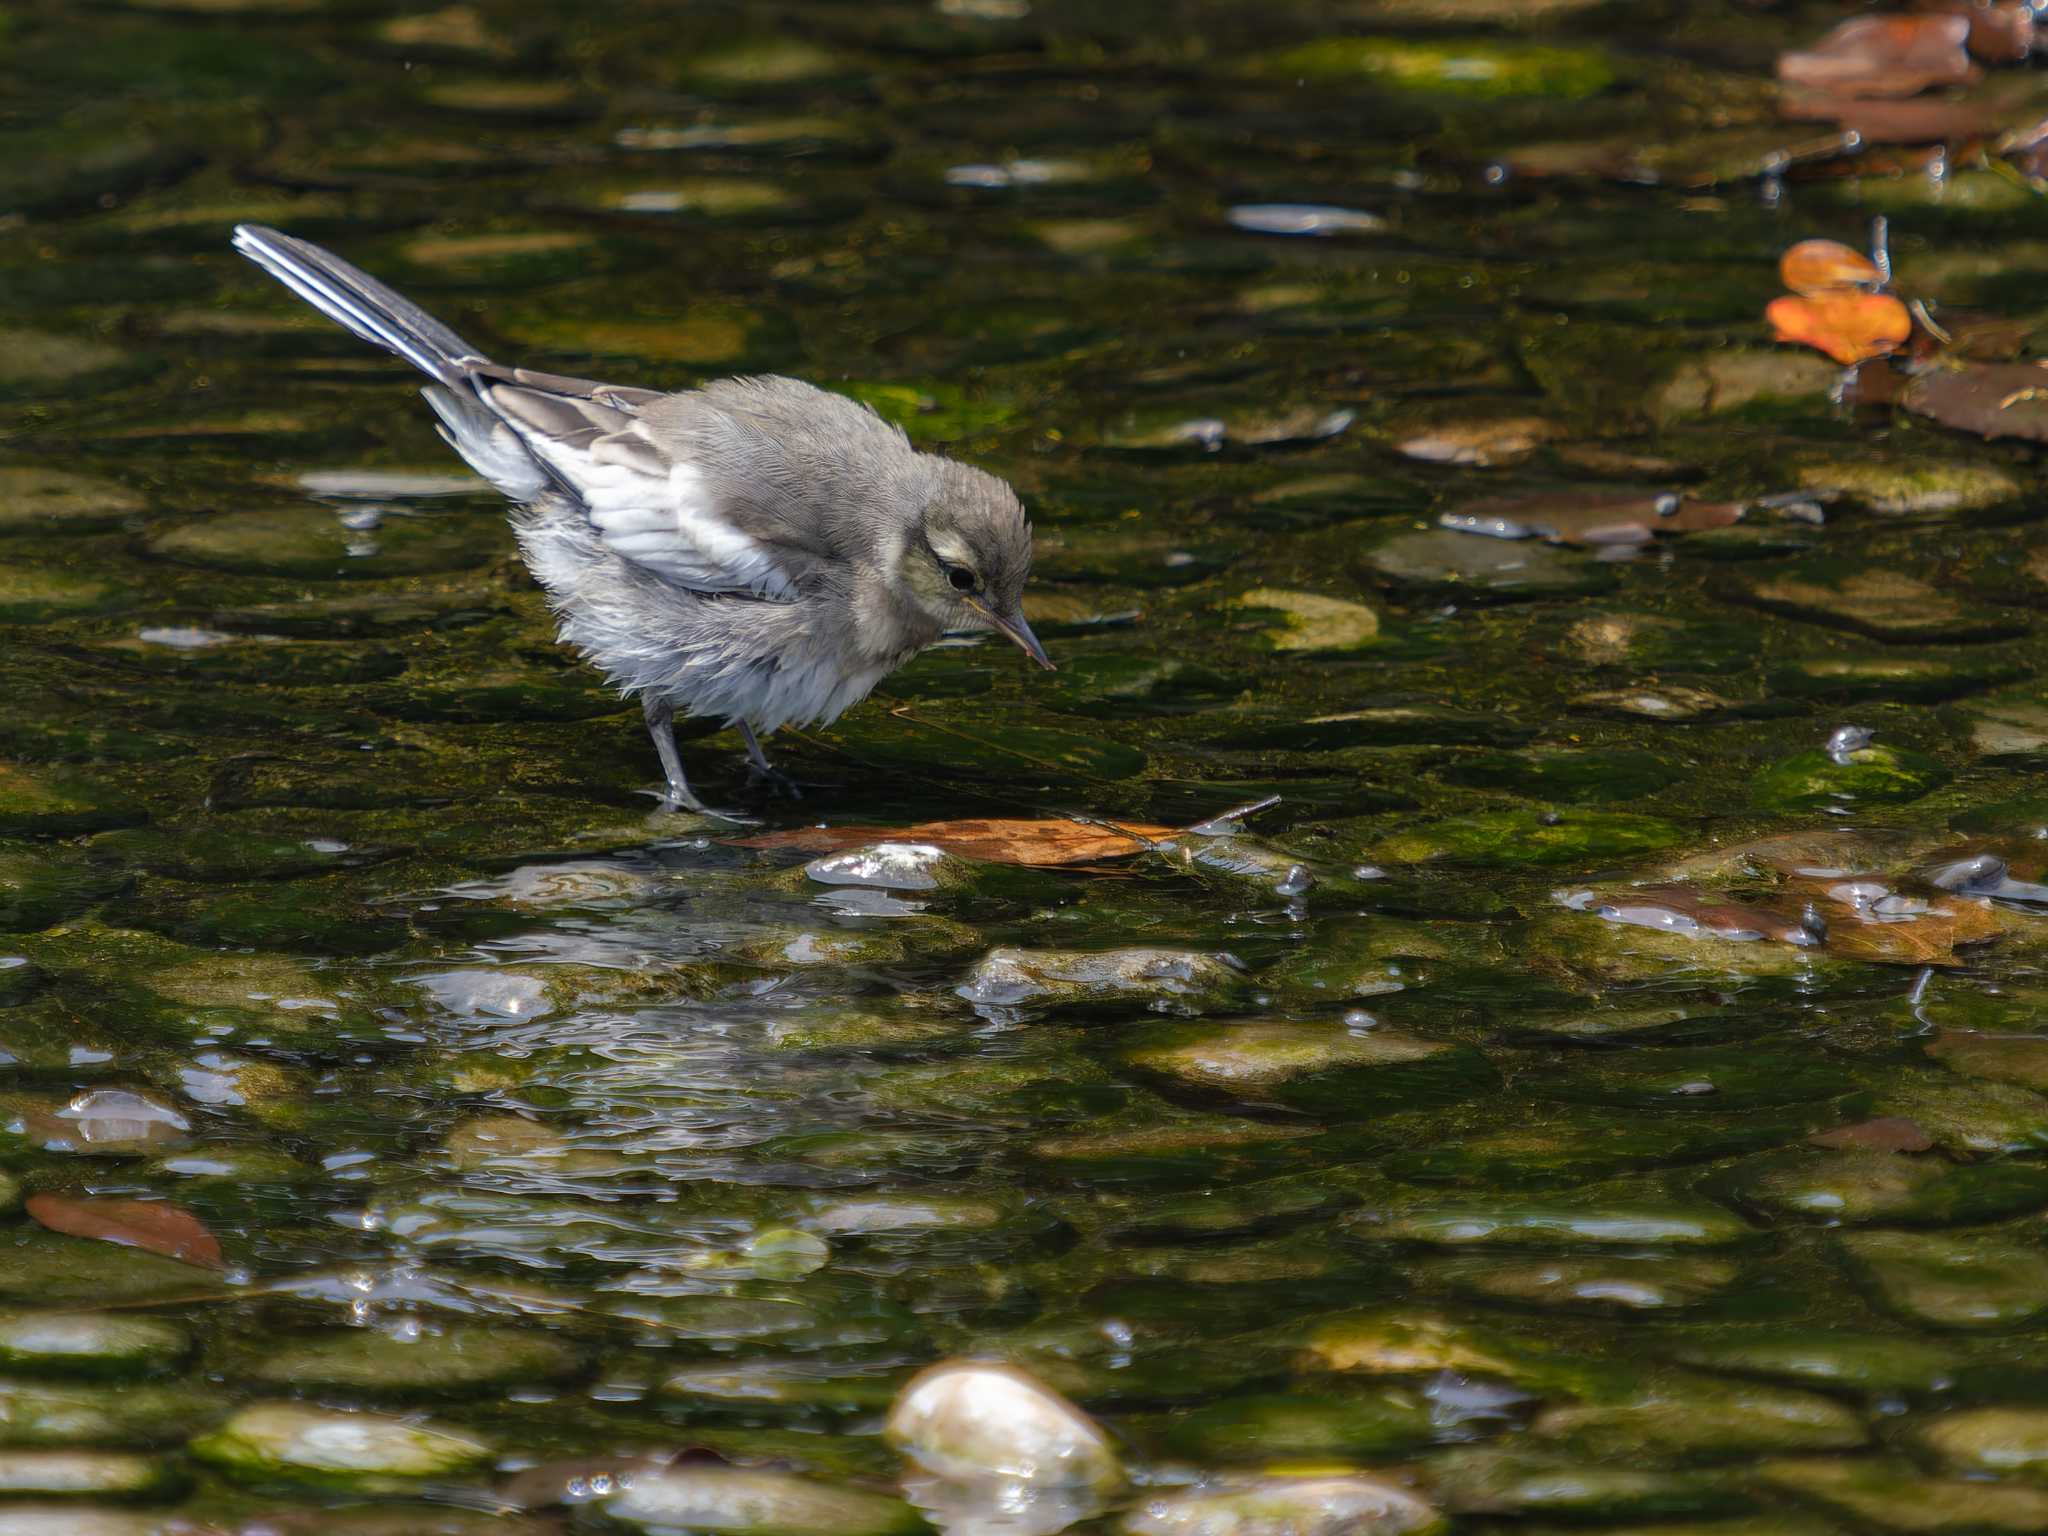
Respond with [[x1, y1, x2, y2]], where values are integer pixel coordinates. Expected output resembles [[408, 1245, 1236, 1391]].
[[883, 1360, 1122, 1493]]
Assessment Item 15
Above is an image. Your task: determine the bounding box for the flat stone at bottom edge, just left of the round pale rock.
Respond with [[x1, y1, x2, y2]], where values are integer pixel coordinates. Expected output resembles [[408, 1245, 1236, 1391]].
[[604, 1464, 926, 1536]]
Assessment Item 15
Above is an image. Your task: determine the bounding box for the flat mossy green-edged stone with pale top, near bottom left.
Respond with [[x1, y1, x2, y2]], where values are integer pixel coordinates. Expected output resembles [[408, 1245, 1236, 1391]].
[[190, 1403, 492, 1487]]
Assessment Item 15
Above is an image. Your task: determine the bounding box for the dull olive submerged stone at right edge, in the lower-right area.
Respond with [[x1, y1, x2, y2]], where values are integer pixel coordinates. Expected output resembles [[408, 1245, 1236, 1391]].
[[1839, 1231, 2048, 1329]]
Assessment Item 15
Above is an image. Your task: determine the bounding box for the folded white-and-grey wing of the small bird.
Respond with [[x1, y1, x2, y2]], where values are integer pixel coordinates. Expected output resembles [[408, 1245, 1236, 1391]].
[[473, 365, 823, 598]]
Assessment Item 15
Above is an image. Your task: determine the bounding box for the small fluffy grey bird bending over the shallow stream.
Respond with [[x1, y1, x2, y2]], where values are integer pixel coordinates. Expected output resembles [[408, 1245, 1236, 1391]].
[[233, 223, 1055, 821]]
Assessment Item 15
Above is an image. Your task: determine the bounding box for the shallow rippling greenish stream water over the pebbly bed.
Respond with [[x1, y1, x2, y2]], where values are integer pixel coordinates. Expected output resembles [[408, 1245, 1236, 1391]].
[[0, 0, 2048, 1536]]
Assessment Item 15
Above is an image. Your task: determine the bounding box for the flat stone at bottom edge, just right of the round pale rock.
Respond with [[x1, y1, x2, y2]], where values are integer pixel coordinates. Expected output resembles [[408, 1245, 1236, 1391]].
[[1122, 1477, 1442, 1536]]
